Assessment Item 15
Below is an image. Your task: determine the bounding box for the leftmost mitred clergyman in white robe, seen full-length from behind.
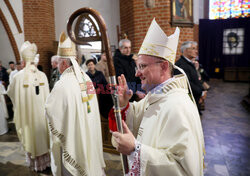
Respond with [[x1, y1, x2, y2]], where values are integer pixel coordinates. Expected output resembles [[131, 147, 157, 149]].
[[7, 41, 50, 171]]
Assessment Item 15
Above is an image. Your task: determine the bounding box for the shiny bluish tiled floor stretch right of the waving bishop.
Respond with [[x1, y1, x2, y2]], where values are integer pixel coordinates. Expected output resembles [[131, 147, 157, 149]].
[[202, 80, 250, 176]]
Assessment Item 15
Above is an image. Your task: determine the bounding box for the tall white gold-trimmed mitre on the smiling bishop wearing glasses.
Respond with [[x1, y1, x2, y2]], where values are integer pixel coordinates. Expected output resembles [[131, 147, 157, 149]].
[[138, 19, 180, 65]]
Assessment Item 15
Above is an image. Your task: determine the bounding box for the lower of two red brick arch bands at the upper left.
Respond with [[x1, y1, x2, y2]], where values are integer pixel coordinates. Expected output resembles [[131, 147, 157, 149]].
[[0, 8, 20, 62]]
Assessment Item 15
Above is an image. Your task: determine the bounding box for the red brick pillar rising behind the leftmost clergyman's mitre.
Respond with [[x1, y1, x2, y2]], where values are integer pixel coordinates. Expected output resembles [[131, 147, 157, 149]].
[[23, 0, 55, 75]]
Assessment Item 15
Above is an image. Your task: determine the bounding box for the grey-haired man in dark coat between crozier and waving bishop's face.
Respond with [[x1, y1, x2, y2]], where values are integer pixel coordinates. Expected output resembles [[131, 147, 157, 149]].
[[114, 39, 141, 102]]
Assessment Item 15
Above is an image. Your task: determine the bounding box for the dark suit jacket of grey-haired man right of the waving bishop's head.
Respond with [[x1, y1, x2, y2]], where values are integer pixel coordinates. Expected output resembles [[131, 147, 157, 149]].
[[174, 56, 203, 104]]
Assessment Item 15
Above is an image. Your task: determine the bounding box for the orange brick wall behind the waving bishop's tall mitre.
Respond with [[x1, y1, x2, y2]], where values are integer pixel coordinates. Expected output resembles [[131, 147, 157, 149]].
[[120, 0, 198, 58]]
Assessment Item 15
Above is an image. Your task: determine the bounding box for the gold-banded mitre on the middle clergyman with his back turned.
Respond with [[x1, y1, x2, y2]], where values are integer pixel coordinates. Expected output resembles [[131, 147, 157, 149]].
[[57, 32, 76, 57]]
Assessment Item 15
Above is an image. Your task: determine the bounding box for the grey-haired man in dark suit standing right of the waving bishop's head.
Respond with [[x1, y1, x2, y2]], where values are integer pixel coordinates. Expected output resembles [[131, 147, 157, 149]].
[[174, 41, 206, 114]]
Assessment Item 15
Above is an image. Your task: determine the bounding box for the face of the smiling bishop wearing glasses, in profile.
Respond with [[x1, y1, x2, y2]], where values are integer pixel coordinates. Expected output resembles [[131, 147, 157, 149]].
[[135, 55, 161, 92]]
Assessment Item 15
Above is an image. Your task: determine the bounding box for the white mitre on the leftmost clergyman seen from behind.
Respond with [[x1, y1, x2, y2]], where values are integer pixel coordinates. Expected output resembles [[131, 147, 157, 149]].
[[20, 41, 37, 62]]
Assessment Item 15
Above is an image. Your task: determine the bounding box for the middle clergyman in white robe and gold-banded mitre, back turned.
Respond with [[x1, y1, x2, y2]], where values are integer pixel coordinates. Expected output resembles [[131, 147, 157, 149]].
[[46, 33, 105, 176]]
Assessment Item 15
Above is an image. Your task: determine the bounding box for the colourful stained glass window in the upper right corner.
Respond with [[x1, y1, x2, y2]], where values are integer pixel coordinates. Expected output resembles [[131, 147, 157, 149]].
[[209, 0, 250, 19]]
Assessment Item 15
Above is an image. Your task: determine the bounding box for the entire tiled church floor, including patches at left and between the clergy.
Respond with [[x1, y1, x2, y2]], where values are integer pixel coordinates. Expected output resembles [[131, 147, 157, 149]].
[[0, 80, 250, 176]]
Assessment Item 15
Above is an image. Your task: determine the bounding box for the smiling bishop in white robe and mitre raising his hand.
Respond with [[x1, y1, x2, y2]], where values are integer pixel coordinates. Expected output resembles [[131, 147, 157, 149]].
[[110, 20, 204, 176]]
